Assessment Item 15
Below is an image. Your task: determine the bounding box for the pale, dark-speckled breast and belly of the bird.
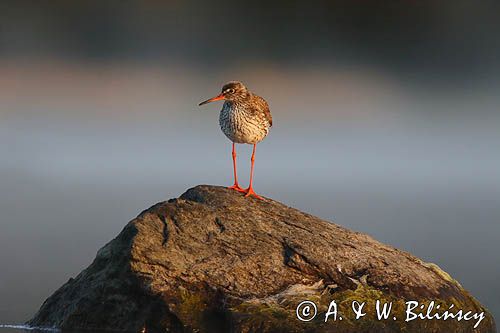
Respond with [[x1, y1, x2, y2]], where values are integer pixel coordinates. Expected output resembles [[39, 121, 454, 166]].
[[219, 101, 270, 144]]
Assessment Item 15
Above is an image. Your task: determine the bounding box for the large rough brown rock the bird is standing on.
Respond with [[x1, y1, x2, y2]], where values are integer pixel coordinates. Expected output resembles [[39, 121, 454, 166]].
[[29, 185, 495, 332]]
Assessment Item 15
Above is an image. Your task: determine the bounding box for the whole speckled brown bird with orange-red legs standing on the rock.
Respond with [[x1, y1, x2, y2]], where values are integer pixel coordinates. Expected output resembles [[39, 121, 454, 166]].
[[199, 81, 273, 200]]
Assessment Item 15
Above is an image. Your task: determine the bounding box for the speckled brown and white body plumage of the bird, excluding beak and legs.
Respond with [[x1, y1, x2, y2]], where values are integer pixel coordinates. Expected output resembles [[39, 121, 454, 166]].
[[219, 82, 273, 144]]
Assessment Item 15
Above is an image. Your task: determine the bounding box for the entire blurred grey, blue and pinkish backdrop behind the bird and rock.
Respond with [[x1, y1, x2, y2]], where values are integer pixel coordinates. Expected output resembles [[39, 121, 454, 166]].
[[0, 0, 500, 324]]
